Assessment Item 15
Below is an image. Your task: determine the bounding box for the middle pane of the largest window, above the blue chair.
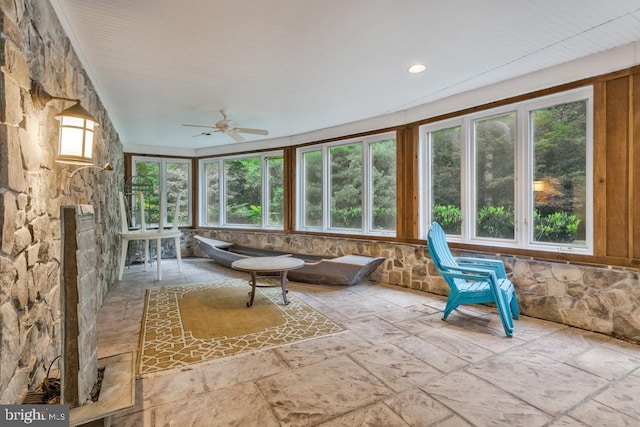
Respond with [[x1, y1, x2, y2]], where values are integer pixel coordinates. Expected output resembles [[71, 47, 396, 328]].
[[474, 113, 516, 239]]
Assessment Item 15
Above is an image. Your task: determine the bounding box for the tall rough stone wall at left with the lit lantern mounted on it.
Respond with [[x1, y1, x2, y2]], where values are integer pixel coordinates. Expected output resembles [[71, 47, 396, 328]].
[[0, 0, 124, 403]]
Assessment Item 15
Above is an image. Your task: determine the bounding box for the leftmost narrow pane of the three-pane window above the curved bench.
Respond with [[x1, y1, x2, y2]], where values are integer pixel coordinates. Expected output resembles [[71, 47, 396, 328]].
[[302, 150, 322, 227]]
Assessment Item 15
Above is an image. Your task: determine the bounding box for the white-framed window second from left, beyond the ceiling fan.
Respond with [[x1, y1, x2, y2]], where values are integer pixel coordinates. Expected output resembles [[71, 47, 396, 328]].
[[200, 152, 284, 229]]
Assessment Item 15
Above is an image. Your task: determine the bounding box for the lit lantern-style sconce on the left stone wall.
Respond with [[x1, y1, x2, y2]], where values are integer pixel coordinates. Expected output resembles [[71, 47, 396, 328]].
[[31, 80, 98, 166]]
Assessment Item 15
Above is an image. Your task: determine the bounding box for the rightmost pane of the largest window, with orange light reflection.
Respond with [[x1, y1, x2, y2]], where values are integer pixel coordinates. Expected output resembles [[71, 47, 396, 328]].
[[531, 101, 587, 244]]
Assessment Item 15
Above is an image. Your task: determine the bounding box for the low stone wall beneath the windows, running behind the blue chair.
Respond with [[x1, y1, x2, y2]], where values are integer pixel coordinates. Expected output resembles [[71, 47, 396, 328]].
[[192, 230, 640, 343]]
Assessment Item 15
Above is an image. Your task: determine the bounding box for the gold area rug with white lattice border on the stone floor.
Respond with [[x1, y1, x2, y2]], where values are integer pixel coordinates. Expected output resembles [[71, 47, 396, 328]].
[[138, 279, 342, 375]]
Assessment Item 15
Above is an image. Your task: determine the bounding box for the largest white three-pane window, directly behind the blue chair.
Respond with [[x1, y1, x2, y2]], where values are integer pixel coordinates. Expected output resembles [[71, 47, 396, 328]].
[[420, 88, 592, 254]]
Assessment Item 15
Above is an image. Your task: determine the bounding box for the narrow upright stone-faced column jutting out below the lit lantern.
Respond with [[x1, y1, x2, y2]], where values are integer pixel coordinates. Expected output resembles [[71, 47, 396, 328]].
[[60, 205, 98, 407]]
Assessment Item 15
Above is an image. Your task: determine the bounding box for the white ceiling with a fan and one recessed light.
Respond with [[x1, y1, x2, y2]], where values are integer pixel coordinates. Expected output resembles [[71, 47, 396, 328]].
[[51, 0, 640, 154]]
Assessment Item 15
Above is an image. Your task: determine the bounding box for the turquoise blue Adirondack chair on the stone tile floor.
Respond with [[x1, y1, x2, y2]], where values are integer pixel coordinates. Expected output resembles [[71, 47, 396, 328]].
[[427, 222, 520, 337]]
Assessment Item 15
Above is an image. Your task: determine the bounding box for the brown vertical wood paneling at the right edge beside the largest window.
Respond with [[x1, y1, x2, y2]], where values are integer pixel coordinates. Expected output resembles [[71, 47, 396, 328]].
[[594, 67, 640, 267]]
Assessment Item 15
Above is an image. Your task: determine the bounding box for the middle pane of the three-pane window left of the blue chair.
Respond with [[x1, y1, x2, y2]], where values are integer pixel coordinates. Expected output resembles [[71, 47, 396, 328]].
[[329, 144, 362, 229]]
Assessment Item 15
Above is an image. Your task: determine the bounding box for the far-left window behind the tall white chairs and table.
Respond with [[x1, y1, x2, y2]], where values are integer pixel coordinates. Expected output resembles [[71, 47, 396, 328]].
[[132, 157, 192, 226]]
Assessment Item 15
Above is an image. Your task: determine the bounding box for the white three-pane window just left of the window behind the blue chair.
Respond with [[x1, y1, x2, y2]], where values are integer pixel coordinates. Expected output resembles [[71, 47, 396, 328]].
[[298, 133, 396, 235]]
